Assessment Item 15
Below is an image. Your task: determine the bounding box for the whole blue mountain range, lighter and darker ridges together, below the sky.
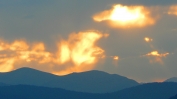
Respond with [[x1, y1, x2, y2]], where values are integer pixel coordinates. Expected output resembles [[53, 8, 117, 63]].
[[0, 68, 177, 99]]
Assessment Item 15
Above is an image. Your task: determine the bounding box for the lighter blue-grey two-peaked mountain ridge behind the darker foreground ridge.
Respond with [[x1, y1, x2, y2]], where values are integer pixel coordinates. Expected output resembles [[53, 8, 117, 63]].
[[0, 67, 138, 93]]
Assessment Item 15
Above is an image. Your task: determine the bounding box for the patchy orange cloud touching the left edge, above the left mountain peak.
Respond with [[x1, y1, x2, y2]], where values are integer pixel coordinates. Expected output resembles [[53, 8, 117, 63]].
[[0, 40, 52, 72]]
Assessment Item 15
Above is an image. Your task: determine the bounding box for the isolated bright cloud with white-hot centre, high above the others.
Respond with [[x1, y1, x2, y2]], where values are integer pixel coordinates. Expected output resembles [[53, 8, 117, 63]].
[[93, 4, 155, 28]]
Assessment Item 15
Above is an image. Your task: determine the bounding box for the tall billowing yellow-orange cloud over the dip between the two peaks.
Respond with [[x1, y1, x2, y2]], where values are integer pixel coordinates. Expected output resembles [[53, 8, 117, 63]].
[[55, 31, 108, 73]]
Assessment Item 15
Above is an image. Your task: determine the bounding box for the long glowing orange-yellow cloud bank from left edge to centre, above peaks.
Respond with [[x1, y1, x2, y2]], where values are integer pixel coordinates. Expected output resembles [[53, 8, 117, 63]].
[[0, 31, 108, 74]]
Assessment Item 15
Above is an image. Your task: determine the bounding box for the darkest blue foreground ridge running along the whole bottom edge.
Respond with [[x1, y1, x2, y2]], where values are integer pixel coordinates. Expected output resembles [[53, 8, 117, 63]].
[[0, 82, 177, 99]]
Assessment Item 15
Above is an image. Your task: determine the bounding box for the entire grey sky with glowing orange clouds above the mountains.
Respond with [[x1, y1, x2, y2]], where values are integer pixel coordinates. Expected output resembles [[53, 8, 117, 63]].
[[0, 0, 177, 82]]
